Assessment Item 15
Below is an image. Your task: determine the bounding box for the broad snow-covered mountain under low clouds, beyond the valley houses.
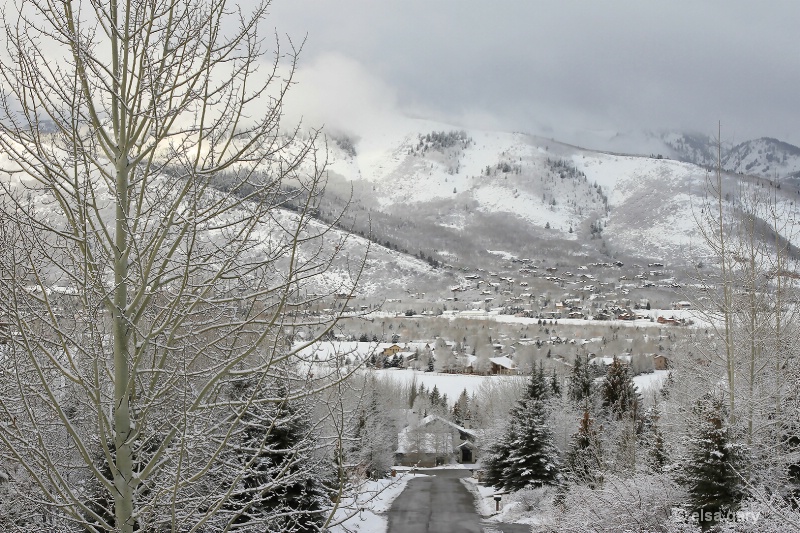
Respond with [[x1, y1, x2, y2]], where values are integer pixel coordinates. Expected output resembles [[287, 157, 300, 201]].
[[318, 120, 794, 267]]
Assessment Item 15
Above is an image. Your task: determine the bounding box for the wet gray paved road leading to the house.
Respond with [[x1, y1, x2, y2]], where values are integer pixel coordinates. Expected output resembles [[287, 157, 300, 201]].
[[387, 469, 530, 533]]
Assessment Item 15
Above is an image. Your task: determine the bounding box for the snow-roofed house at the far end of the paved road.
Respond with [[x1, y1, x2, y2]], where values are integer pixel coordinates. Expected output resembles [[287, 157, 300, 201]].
[[395, 415, 477, 467]]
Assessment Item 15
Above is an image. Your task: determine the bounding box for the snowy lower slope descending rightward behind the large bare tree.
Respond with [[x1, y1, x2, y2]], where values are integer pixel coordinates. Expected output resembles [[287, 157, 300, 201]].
[[0, 137, 452, 306]]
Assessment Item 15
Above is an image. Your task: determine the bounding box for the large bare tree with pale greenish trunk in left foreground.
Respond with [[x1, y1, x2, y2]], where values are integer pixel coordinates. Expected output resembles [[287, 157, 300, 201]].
[[0, 0, 363, 531]]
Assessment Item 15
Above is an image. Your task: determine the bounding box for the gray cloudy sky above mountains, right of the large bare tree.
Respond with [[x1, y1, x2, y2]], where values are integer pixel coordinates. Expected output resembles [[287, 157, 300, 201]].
[[268, 0, 800, 150]]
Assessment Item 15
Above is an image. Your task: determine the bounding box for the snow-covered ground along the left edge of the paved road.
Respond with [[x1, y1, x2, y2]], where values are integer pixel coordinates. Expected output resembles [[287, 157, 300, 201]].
[[329, 468, 425, 533]]
